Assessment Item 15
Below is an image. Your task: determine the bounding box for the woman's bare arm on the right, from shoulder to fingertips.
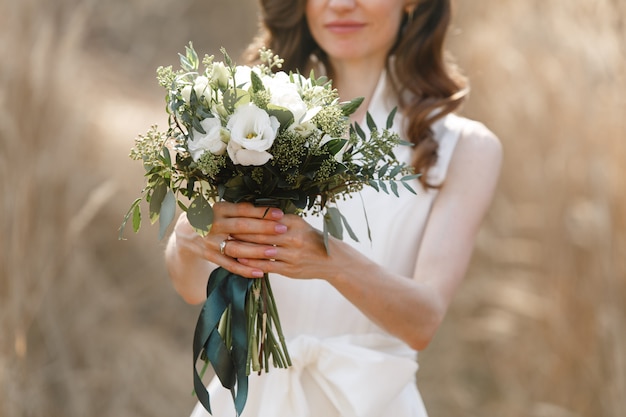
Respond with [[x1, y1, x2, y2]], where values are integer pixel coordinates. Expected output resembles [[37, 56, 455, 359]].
[[230, 123, 502, 350]]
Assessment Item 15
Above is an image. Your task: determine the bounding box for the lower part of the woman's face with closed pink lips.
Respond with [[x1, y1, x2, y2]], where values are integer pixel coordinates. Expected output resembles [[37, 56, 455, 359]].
[[306, 0, 414, 62]]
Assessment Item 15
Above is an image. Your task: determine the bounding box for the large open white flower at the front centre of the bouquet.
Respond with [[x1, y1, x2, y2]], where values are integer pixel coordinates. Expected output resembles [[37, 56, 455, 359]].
[[226, 104, 280, 166]]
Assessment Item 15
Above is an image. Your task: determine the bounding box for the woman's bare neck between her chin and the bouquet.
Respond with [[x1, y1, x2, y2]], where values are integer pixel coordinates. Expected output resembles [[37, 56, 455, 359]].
[[330, 57, 385, 122]]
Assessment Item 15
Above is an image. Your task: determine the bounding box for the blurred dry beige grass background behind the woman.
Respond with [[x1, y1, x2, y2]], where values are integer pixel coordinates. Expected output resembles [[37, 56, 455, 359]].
[[0, 0, 626, 417]]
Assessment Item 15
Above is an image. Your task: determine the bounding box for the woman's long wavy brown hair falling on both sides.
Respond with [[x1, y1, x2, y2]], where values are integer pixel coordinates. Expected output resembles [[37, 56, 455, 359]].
[[246, 0, 468, 187]]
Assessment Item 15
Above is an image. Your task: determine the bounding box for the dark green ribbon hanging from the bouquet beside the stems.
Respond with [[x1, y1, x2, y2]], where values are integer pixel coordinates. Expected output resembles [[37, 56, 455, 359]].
[[193, 267, 253, 415]]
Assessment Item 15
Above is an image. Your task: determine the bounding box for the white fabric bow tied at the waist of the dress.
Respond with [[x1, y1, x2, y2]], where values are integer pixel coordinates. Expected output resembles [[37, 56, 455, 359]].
[[251, 334, 417, 417]]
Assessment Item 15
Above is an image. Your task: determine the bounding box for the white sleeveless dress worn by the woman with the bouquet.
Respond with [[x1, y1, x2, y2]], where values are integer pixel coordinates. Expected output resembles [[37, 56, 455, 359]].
[[191, 74, 469, 417]]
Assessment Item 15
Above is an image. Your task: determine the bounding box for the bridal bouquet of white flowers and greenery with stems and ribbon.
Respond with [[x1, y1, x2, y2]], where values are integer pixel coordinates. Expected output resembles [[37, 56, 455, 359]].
[[120, 44, 416, 414]]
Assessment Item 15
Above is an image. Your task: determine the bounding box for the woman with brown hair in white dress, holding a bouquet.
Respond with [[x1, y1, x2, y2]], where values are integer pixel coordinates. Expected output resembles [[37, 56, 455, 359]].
[[166, 0, 502, 417]]
